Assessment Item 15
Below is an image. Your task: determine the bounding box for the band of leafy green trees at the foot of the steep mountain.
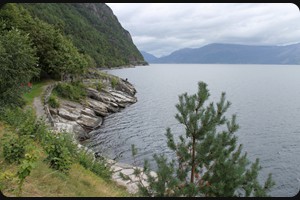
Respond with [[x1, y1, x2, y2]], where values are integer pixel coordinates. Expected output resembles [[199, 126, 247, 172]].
[[0, 4, 92, 80]]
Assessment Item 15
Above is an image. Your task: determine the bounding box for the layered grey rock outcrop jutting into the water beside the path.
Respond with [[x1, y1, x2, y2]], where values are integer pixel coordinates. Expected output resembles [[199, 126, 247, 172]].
[[49, 73, 137, 141]]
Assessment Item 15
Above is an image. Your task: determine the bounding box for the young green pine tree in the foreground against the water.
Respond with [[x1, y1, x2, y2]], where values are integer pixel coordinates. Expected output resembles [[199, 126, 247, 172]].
[[122, 82, 275, 197]]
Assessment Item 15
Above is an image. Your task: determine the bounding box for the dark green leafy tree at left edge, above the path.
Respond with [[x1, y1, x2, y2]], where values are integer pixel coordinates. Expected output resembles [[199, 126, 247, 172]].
[[0, 21, 39, 107]]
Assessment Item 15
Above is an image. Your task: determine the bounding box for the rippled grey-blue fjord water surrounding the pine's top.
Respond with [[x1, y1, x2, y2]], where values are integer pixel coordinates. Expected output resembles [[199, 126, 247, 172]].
[[88, 64, 300, 197]]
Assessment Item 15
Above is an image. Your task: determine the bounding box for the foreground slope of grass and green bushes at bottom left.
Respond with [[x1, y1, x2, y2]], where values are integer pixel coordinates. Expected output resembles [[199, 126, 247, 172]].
[[0, 108, 129, 197]]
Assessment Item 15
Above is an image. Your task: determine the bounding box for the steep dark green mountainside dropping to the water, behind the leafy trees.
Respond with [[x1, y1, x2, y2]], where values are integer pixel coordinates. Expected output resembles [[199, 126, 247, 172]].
[[20, 3, 147, 67]]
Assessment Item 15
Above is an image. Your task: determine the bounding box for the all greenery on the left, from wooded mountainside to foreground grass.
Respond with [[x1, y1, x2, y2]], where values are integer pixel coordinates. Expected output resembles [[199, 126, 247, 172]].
[[0, 3, 144, 196]]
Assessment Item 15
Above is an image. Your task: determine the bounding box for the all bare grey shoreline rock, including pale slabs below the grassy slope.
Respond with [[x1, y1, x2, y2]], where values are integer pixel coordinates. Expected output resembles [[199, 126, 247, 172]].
[[43, 69, 155, 194]]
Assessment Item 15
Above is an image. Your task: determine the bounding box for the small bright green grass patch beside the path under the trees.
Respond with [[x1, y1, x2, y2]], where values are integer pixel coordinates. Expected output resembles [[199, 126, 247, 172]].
[[24, 80, 54, 105]]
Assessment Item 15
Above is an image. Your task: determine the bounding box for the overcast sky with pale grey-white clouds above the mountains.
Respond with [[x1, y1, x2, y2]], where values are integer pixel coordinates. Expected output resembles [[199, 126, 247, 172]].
[[107, 3, 300, 57]]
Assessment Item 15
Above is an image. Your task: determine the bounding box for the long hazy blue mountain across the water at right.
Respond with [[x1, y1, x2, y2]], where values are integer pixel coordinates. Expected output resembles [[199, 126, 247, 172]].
[[150, 43, 300, 64]]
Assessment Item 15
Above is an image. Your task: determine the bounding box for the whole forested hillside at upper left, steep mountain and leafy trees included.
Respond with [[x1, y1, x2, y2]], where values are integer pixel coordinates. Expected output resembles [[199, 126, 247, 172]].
[[0, 3, 146, 104]]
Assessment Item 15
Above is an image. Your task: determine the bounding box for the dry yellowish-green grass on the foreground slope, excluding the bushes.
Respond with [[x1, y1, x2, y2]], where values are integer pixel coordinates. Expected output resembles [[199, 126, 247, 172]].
[[0, 122, 131, 197]]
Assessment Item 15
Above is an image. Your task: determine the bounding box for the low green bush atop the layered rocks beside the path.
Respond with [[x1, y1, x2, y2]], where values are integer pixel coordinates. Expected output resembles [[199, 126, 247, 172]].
[[54, 82, 86, 102]]
